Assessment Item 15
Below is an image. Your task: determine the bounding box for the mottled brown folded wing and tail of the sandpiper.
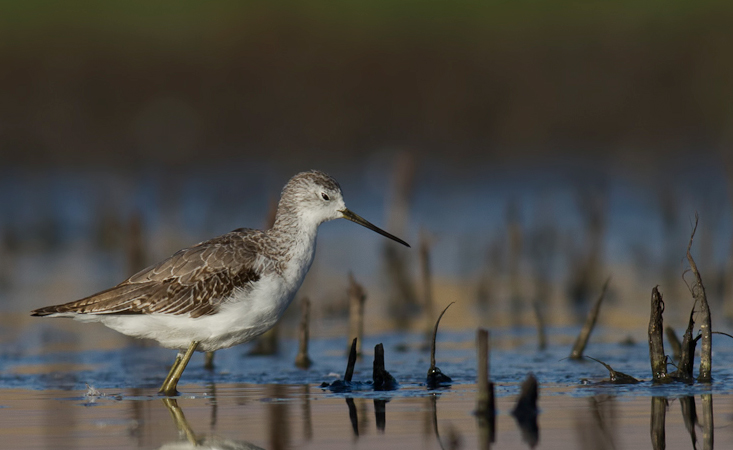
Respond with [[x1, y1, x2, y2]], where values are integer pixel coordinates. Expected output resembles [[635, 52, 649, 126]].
[[32, 229, 264, 317]]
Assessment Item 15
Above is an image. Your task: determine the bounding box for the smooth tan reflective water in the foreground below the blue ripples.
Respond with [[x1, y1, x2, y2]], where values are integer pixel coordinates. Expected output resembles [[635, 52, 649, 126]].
[[0, 384, 733, 450]]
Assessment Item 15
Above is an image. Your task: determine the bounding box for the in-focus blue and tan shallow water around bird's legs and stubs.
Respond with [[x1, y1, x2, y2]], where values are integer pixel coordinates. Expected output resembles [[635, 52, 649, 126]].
[[0, 321, 733, 449]]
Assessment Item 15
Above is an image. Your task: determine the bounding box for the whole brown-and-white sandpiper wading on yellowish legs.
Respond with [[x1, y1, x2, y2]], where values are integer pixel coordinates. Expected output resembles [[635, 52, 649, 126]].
[[31, 170, 409, 396]]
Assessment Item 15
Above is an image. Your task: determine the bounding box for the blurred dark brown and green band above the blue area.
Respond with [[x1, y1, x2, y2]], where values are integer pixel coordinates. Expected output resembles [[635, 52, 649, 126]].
[[0, 0, 733, 168]]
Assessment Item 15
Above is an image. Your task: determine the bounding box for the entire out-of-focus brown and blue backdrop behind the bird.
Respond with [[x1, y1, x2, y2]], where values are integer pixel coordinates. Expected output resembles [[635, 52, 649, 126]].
[[0, 0, 733, 330]]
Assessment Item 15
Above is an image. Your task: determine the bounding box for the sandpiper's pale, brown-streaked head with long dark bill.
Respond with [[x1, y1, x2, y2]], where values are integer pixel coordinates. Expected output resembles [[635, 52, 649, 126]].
[[275, 170, 409, 247]]
